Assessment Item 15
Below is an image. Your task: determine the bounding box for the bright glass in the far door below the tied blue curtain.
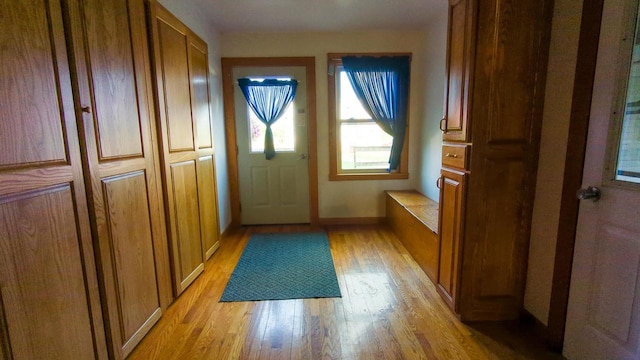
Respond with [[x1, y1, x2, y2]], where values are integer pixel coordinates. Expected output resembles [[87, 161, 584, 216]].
[[247, 103, 296, 153]]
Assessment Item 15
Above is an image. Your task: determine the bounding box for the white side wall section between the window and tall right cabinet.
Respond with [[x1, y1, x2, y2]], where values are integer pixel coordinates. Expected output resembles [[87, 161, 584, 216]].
[[418, 12, 448, 201]]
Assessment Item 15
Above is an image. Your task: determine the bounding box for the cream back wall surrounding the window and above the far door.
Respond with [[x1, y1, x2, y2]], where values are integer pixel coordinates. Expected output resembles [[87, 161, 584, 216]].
[[221, 31, 425, 218]]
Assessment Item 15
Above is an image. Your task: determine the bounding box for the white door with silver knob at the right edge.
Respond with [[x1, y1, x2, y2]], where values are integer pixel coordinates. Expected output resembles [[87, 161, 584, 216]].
[[564, 0, 640, 359]]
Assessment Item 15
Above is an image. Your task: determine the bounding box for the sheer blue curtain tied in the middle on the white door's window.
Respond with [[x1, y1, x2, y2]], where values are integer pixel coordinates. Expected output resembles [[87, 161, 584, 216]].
[[238, 78, 298, 160]]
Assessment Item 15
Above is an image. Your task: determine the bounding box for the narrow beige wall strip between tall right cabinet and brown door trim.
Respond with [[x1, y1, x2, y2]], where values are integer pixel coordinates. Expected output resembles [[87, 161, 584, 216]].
[[524, 0, 582, 324]]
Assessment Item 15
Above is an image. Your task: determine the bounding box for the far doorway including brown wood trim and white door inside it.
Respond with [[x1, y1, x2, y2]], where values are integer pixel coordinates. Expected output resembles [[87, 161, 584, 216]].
[[222, 57, 319, 226]]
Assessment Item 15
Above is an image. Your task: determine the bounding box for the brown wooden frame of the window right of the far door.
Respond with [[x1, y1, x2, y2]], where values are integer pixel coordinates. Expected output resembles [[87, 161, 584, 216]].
[[327, 53, 411, 181]]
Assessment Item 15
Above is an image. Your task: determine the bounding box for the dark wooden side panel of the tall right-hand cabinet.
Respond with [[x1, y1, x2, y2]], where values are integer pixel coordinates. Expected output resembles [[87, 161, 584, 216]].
[[459, 0, 553, 321]]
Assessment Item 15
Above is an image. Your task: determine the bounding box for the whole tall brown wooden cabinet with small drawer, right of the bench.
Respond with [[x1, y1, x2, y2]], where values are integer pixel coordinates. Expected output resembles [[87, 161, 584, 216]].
[[437, 0, 553, 321]]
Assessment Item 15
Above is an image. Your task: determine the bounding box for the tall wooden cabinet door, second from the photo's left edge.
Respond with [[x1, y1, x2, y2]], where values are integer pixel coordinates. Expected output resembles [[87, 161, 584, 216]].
[[69, 0, 172, 358]]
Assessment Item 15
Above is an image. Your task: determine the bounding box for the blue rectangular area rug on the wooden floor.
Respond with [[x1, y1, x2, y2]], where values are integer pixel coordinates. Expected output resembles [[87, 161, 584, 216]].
[[220, 233, 341, 302]]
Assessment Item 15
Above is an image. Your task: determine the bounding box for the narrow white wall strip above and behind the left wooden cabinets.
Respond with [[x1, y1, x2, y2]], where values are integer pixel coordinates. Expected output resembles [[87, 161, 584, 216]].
[[159, 0, 231, 231]]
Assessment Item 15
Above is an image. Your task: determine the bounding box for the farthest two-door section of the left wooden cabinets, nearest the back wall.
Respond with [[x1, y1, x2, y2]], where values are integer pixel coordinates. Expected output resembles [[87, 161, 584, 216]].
[[149, 3, 219, 294]]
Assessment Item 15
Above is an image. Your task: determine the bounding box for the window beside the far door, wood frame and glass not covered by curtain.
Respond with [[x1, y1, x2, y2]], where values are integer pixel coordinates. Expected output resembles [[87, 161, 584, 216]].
[[328, 54, 408, 180]]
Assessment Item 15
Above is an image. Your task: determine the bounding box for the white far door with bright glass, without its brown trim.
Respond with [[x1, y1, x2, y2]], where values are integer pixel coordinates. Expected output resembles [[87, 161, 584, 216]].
[[233, 66, 309, 225]]
